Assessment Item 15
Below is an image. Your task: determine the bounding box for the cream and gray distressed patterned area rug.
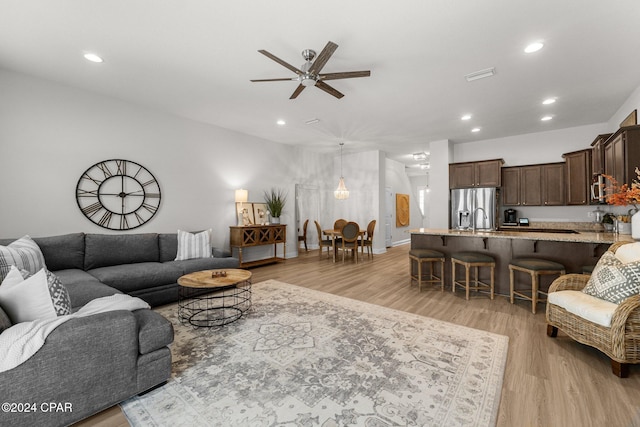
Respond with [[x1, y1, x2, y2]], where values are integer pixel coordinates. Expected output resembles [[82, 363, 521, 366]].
[[121, 280, 508, 427]]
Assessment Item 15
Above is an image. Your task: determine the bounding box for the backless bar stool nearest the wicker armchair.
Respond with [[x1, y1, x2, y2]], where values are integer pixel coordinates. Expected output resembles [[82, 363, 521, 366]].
[[509, 258, 565, 314]]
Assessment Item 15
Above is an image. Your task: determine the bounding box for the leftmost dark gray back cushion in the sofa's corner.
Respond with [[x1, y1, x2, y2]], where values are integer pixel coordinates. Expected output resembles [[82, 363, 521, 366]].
[[33, 233, 84, 271]]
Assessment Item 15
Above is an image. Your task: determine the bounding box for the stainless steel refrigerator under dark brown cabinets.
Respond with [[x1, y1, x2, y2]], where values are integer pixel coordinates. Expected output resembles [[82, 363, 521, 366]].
[[451, 187, 498, 230]]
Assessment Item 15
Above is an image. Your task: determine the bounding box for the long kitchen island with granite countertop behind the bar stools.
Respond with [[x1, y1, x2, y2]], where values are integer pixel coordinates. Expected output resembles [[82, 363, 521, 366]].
[[409, 228, 633, 295]]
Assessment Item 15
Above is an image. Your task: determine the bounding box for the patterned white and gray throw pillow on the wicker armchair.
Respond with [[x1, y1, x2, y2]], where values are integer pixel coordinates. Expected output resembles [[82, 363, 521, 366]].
[[582, 252, 640, 304]]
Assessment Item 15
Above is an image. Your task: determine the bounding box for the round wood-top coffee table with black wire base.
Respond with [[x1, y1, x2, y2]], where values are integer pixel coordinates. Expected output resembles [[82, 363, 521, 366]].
[[178, 268, 251, 327]]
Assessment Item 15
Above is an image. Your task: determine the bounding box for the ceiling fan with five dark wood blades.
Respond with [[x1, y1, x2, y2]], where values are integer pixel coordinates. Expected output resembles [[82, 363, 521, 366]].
[[251, 42, 371, 99]]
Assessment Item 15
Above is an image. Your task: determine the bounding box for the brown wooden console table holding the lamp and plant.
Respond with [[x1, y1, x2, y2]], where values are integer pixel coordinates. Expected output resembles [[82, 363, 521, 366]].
[[229, 224, 287, 268]]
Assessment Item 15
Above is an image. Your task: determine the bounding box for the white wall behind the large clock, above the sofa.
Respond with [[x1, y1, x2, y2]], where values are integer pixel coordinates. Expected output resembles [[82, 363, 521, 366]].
[[0, 70, 330, 260]]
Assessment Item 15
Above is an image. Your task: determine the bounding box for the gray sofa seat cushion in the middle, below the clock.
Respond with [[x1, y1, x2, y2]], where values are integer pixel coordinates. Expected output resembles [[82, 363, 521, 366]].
[[88, 262, 182, 293]]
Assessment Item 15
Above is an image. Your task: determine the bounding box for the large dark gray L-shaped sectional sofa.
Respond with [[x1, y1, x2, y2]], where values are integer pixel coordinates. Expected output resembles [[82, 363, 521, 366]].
[[0, 233, 238, 426]]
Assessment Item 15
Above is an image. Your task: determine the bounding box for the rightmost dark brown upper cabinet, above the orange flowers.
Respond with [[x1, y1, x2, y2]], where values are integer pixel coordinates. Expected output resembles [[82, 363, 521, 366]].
[[603, 125, 640, 185]]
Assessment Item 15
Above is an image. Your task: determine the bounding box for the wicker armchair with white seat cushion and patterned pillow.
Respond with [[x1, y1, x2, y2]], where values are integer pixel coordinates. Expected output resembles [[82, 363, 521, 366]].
[[546, 243, 640, 378]]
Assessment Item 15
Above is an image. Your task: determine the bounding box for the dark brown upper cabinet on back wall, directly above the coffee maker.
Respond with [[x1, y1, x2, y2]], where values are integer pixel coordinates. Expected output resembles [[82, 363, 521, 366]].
[[501, 163, 565, 206]]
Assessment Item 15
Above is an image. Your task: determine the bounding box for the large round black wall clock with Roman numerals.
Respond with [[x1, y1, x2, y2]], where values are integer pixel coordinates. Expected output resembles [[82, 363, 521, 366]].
[[76, 159, 160, 230]]
